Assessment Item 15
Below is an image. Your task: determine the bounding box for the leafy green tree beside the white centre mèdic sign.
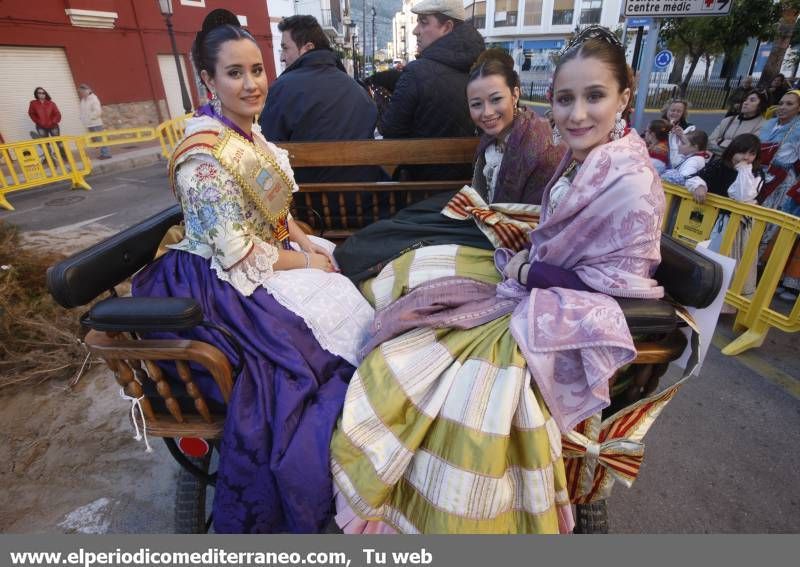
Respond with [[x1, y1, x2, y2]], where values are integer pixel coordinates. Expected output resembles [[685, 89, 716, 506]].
[[662, 0, 780, 94]]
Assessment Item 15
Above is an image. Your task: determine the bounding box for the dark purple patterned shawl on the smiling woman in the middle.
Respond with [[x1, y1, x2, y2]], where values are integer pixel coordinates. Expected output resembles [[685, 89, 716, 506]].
[[472, 108, 566, 205]]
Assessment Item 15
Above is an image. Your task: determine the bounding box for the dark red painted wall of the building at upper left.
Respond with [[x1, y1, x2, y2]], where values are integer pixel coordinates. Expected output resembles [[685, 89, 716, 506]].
[[0, 0, 276, 126]]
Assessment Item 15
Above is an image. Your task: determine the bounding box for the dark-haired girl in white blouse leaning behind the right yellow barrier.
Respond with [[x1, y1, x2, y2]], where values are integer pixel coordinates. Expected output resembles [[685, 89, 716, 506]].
[[686, 134, 763, 312]]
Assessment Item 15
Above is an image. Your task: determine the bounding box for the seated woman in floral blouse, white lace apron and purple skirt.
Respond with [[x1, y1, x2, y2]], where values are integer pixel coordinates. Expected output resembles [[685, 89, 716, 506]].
[[132, 10, 373, 533]]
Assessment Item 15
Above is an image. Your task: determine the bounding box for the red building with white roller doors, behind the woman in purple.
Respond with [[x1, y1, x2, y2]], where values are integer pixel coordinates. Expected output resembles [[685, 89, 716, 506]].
[[0, 0, 275, 142]]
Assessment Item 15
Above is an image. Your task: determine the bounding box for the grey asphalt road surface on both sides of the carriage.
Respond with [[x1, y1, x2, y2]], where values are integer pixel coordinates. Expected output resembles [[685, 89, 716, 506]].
[[0, 163, 800, 533]]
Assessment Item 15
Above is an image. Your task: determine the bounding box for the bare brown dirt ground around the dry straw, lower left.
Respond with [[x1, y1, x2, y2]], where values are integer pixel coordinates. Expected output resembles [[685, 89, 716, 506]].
[[0, 224, 177, 533]]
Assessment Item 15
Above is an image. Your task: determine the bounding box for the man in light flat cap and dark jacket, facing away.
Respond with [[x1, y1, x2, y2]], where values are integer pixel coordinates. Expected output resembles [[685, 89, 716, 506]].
[[378, 0, 484, 180]]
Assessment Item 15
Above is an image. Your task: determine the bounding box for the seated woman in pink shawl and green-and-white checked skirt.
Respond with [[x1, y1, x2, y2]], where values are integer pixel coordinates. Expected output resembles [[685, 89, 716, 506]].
[[331, 27, 664, 533]]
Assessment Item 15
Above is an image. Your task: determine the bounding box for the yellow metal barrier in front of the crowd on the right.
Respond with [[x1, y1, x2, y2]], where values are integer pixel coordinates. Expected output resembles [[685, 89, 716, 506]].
[[662, 183, 800, 355]]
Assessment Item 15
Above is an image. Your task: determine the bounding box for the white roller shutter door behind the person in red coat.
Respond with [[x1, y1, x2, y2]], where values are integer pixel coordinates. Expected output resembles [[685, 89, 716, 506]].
[[0, 46, 86, 143]]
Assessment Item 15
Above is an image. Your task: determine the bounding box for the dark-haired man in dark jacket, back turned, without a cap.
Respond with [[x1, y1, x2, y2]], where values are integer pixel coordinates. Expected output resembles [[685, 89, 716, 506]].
[[259, 16, 380, 183]]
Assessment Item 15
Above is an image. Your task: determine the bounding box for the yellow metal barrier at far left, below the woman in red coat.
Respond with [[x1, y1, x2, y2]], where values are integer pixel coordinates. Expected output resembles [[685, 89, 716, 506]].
[[0, 136, 92, 211]]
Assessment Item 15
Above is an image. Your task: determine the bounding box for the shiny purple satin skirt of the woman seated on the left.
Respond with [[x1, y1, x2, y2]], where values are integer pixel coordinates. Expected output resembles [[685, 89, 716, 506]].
[[132, 251, 355, 533]]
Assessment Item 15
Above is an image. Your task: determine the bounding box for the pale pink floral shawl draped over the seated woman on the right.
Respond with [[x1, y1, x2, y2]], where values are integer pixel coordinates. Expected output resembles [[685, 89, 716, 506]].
[[510, 131, 665, 432]]
